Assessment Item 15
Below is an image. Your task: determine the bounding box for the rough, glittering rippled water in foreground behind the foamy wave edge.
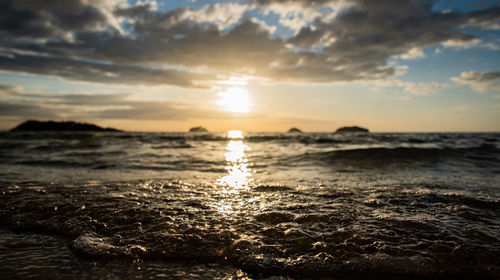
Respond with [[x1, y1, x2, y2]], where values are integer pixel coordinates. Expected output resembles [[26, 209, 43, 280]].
[[0, 181, 500, 279]]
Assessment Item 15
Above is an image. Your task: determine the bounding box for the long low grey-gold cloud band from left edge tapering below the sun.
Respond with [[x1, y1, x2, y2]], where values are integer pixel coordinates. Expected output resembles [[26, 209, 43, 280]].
[[0, 84, 229, 120]]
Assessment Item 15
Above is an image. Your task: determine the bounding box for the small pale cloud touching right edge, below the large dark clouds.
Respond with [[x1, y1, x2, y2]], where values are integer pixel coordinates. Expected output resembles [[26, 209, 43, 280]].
[[451, 71, 500, 92]]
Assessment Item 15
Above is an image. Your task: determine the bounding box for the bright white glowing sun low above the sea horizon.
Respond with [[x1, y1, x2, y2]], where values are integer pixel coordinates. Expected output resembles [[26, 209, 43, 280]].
[[217, 87, 251, 113]]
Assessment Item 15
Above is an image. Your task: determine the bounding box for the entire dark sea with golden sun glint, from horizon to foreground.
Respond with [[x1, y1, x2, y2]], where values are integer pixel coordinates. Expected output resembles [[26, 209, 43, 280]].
[[0, 131, 500, 279]]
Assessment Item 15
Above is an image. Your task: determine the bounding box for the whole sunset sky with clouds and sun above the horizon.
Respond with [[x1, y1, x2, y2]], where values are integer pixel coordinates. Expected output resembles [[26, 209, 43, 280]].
[[0, 0, 500, 132]]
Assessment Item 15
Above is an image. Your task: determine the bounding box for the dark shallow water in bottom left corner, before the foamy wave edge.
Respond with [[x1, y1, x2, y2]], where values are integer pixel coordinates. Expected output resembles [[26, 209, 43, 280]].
[[0, 230, 248, 279]]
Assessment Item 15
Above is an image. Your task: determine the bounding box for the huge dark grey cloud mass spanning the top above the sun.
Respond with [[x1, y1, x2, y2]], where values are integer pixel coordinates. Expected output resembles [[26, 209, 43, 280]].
[[0, 0, 500, 87]]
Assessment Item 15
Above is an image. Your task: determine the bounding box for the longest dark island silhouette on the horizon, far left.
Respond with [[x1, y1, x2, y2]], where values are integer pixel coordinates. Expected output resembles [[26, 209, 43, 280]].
[[10, 120, 121, 132]]
